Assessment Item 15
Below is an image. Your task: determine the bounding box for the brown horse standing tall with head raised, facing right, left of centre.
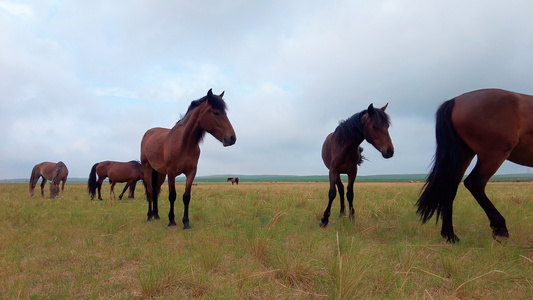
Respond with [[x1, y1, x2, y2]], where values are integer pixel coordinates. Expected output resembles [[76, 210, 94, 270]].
[[141, 90, 236, 229]]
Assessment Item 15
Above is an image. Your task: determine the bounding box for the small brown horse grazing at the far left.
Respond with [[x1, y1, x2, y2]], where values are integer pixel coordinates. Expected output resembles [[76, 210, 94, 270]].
[[30, 161, 68, 198]]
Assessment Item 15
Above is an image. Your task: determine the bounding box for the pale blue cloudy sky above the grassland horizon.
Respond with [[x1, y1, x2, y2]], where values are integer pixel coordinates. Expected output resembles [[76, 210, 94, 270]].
[[0, 0, 533, 179]]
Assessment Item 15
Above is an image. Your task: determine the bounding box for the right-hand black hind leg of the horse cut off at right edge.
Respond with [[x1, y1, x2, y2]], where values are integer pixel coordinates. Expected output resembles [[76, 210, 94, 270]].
[[464, 156, 509, 243]]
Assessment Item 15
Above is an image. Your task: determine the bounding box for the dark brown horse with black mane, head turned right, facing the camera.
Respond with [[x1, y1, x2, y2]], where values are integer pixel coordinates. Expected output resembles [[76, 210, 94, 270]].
[[320, 103, 394, 227]]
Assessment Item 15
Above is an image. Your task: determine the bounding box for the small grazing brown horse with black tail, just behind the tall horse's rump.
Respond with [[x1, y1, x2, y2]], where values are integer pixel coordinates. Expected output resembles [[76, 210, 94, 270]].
[[87, 160, 144, 200]]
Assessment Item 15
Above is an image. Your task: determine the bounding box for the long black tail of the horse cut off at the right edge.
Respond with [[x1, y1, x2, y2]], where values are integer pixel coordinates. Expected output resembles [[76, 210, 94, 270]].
[[416, 99, 468, 223]]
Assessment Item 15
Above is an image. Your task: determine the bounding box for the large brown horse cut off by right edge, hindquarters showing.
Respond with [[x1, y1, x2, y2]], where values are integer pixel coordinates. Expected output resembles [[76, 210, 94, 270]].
[[416, 89, 533, 243]]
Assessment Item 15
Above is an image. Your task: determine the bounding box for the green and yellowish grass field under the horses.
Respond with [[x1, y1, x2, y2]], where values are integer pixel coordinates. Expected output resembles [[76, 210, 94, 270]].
[[0, 182, 533, 299]]
